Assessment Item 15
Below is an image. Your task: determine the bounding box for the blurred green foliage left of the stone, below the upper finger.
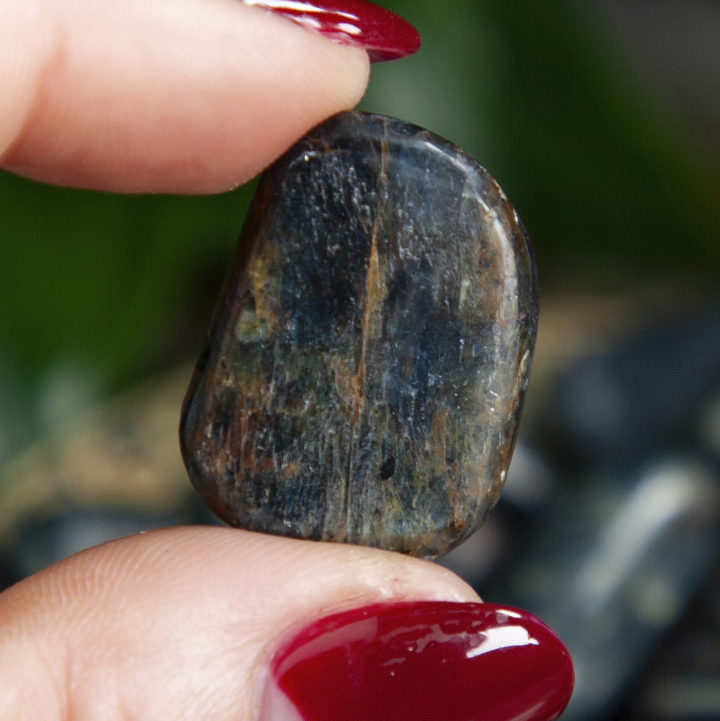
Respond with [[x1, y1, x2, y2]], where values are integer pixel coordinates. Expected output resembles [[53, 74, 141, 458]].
[[0, 180, 251, 460]]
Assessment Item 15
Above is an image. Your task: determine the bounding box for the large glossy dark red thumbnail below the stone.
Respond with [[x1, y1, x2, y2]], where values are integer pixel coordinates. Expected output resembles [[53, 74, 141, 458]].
[[261, 602, 573, 721]]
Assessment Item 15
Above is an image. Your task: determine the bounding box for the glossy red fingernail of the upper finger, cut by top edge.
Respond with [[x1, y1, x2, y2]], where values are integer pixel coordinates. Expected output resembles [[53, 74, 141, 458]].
[[243, 0, 420, 63]]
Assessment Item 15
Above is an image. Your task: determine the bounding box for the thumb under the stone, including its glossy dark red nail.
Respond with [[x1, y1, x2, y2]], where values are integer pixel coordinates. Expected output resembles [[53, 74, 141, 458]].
[[0, 528, 569, 721]]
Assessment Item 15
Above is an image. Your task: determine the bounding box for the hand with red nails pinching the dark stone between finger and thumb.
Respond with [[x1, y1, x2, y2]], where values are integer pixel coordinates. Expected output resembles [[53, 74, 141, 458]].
[[0, 0, 571, 721]]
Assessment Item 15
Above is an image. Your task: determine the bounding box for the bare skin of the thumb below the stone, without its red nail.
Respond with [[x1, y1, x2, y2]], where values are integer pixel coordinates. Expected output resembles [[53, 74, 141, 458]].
[[0, 527, 478, 721]]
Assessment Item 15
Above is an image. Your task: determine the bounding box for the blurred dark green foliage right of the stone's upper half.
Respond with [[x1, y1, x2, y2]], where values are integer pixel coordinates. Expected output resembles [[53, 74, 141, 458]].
[[364, 0, 720, 285]]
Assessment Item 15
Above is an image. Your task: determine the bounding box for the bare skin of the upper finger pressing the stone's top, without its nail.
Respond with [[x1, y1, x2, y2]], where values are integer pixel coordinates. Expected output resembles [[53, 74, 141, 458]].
[[0, 0, 369, 193]]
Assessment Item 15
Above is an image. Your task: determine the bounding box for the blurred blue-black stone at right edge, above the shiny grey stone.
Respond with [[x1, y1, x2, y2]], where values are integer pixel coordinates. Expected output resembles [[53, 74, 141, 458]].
[[548, 302, 720, 468]]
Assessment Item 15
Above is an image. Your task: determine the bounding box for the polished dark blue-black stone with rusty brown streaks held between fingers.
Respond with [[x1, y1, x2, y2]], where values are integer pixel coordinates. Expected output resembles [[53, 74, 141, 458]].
[[181, 112, 537, 557]]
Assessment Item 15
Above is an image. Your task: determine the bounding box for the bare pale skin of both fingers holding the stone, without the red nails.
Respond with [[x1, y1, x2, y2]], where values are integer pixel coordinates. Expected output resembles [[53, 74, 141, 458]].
[[0, 0, 484, 721]]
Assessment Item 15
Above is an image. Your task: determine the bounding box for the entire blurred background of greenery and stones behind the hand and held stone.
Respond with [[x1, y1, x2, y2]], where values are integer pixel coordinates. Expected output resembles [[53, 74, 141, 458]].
[[0, 0, 720, 720]]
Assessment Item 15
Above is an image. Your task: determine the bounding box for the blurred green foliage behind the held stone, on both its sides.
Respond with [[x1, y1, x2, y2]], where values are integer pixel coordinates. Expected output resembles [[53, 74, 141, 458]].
[[0, 0, 720, 459]]
